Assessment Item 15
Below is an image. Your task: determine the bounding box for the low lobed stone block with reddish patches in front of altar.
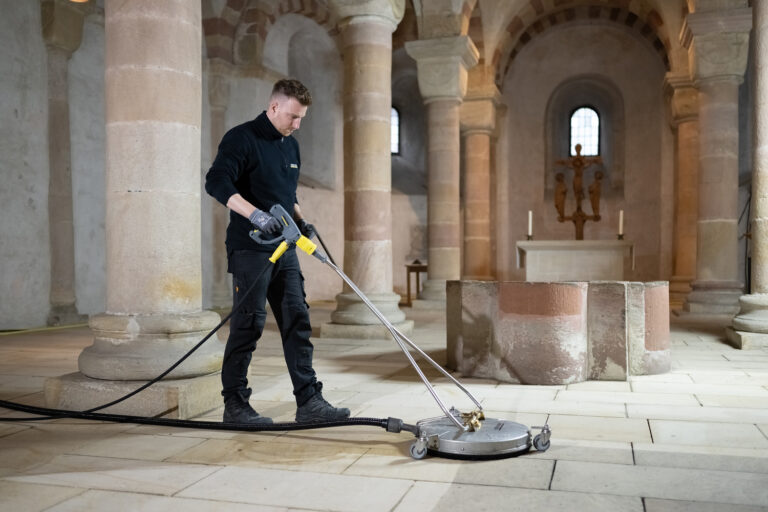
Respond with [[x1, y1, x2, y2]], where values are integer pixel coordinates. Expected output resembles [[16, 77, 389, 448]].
[[446, 281, 670, 385]]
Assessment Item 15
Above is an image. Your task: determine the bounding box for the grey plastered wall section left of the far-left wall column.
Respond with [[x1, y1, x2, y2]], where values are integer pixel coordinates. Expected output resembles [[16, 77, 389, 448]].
[[0, 1, 50, 329]]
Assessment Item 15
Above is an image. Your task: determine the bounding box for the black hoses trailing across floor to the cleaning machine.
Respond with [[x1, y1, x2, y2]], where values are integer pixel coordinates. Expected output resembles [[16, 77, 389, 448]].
[[0, 232, 418, 435]]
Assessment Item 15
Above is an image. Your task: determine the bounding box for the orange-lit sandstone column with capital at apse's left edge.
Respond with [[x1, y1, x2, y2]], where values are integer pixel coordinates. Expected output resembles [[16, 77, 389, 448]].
[[459, 67, 501, 281]]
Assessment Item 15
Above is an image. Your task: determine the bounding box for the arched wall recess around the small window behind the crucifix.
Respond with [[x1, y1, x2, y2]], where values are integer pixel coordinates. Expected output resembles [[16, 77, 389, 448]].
[[544, 75, 625, 197]]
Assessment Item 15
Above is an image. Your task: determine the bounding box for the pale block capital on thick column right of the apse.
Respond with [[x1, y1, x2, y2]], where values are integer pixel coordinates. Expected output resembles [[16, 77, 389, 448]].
[[680, 7, 752, 83]]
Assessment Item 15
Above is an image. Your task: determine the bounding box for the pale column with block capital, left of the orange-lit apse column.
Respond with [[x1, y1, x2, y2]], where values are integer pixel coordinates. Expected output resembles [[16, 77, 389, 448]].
[[405, 36, 479, 308]]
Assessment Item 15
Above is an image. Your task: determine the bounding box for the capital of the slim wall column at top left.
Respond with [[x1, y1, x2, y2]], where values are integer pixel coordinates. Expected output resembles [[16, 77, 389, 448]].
[[40, 0, 89, 55]]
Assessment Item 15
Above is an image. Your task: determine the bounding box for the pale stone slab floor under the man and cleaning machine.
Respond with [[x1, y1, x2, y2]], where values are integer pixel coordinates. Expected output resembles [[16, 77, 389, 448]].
[[0, 305, 768, 512]]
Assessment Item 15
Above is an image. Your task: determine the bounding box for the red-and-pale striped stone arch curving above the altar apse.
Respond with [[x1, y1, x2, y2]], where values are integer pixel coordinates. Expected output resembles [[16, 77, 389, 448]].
[[491, 0, 672, 87]]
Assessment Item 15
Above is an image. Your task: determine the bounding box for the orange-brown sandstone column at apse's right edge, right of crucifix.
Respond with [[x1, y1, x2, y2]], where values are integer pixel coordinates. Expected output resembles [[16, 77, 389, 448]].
[[666, 74, 699, 308]]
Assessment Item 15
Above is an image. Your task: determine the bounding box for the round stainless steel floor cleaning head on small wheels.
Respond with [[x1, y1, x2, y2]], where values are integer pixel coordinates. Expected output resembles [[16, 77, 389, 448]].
[[411, 417, 531, 459]]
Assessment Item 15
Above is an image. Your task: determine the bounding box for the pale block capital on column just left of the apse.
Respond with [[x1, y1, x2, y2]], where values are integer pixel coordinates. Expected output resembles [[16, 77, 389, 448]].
[[405, 36, 480, 102]]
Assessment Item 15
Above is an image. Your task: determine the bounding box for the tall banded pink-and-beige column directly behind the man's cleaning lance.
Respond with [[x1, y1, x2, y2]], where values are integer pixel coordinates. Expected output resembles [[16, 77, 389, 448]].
[[320, 0, 413, 338]]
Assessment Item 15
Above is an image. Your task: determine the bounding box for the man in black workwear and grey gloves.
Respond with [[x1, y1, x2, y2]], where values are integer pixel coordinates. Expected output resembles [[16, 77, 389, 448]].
[[205, 79, 349, 423]]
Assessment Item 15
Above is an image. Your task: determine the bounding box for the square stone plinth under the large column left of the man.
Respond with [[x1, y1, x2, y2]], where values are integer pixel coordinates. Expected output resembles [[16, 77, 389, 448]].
[[45, 372, 223, 419]]
